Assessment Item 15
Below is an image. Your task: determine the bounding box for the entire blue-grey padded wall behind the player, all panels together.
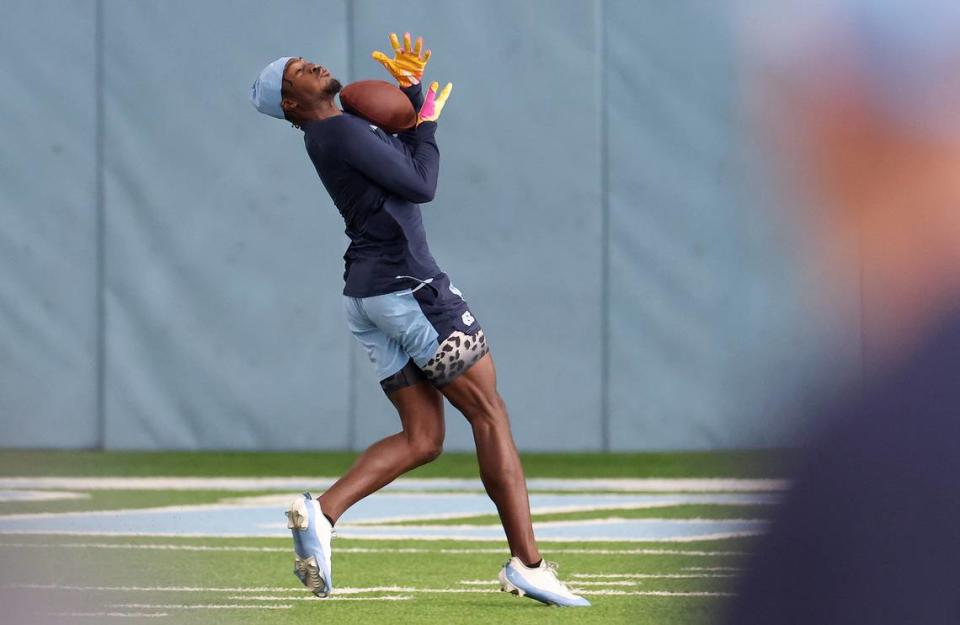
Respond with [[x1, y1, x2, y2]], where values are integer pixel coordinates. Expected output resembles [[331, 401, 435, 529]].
[[0, 0, 858, 450]]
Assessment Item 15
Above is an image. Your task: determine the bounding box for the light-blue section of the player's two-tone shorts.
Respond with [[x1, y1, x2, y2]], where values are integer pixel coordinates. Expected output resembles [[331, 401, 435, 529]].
[[343, 289, 439, 380]]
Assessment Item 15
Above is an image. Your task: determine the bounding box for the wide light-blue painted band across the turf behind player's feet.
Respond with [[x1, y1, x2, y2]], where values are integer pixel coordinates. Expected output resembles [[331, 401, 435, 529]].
[[0, 493, 777, 540]]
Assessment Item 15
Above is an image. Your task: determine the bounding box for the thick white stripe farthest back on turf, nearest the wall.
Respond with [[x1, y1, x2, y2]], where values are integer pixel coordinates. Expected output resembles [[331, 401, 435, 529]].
[[0, 476, 789, 492]]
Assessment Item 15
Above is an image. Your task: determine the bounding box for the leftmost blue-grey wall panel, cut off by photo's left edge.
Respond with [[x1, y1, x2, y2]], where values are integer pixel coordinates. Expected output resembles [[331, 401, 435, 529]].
[[0, 0, 99, 447]]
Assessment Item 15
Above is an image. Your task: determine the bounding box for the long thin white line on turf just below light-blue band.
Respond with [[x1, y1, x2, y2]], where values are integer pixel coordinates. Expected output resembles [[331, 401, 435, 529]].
[[0, 542, 746, 556]]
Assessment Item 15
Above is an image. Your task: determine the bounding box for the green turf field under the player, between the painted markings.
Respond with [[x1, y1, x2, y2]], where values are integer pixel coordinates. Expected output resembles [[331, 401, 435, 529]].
[[0, 452, 779, 625]]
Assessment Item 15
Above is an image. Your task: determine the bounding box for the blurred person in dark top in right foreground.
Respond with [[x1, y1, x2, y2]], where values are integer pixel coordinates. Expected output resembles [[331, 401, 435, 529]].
[[726, 0, 960, 625]]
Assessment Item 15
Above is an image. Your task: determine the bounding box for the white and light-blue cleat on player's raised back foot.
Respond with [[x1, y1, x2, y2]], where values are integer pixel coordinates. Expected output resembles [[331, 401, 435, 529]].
[[287, 493, 334, 597]]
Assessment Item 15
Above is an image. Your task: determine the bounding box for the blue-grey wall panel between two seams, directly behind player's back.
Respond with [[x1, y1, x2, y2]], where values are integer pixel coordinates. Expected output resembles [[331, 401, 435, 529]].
[[105, 0, 349, 449]]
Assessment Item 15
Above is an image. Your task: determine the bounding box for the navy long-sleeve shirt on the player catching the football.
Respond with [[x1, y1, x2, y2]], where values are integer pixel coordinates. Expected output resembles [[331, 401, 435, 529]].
[[303, 85, 441, 297]]
